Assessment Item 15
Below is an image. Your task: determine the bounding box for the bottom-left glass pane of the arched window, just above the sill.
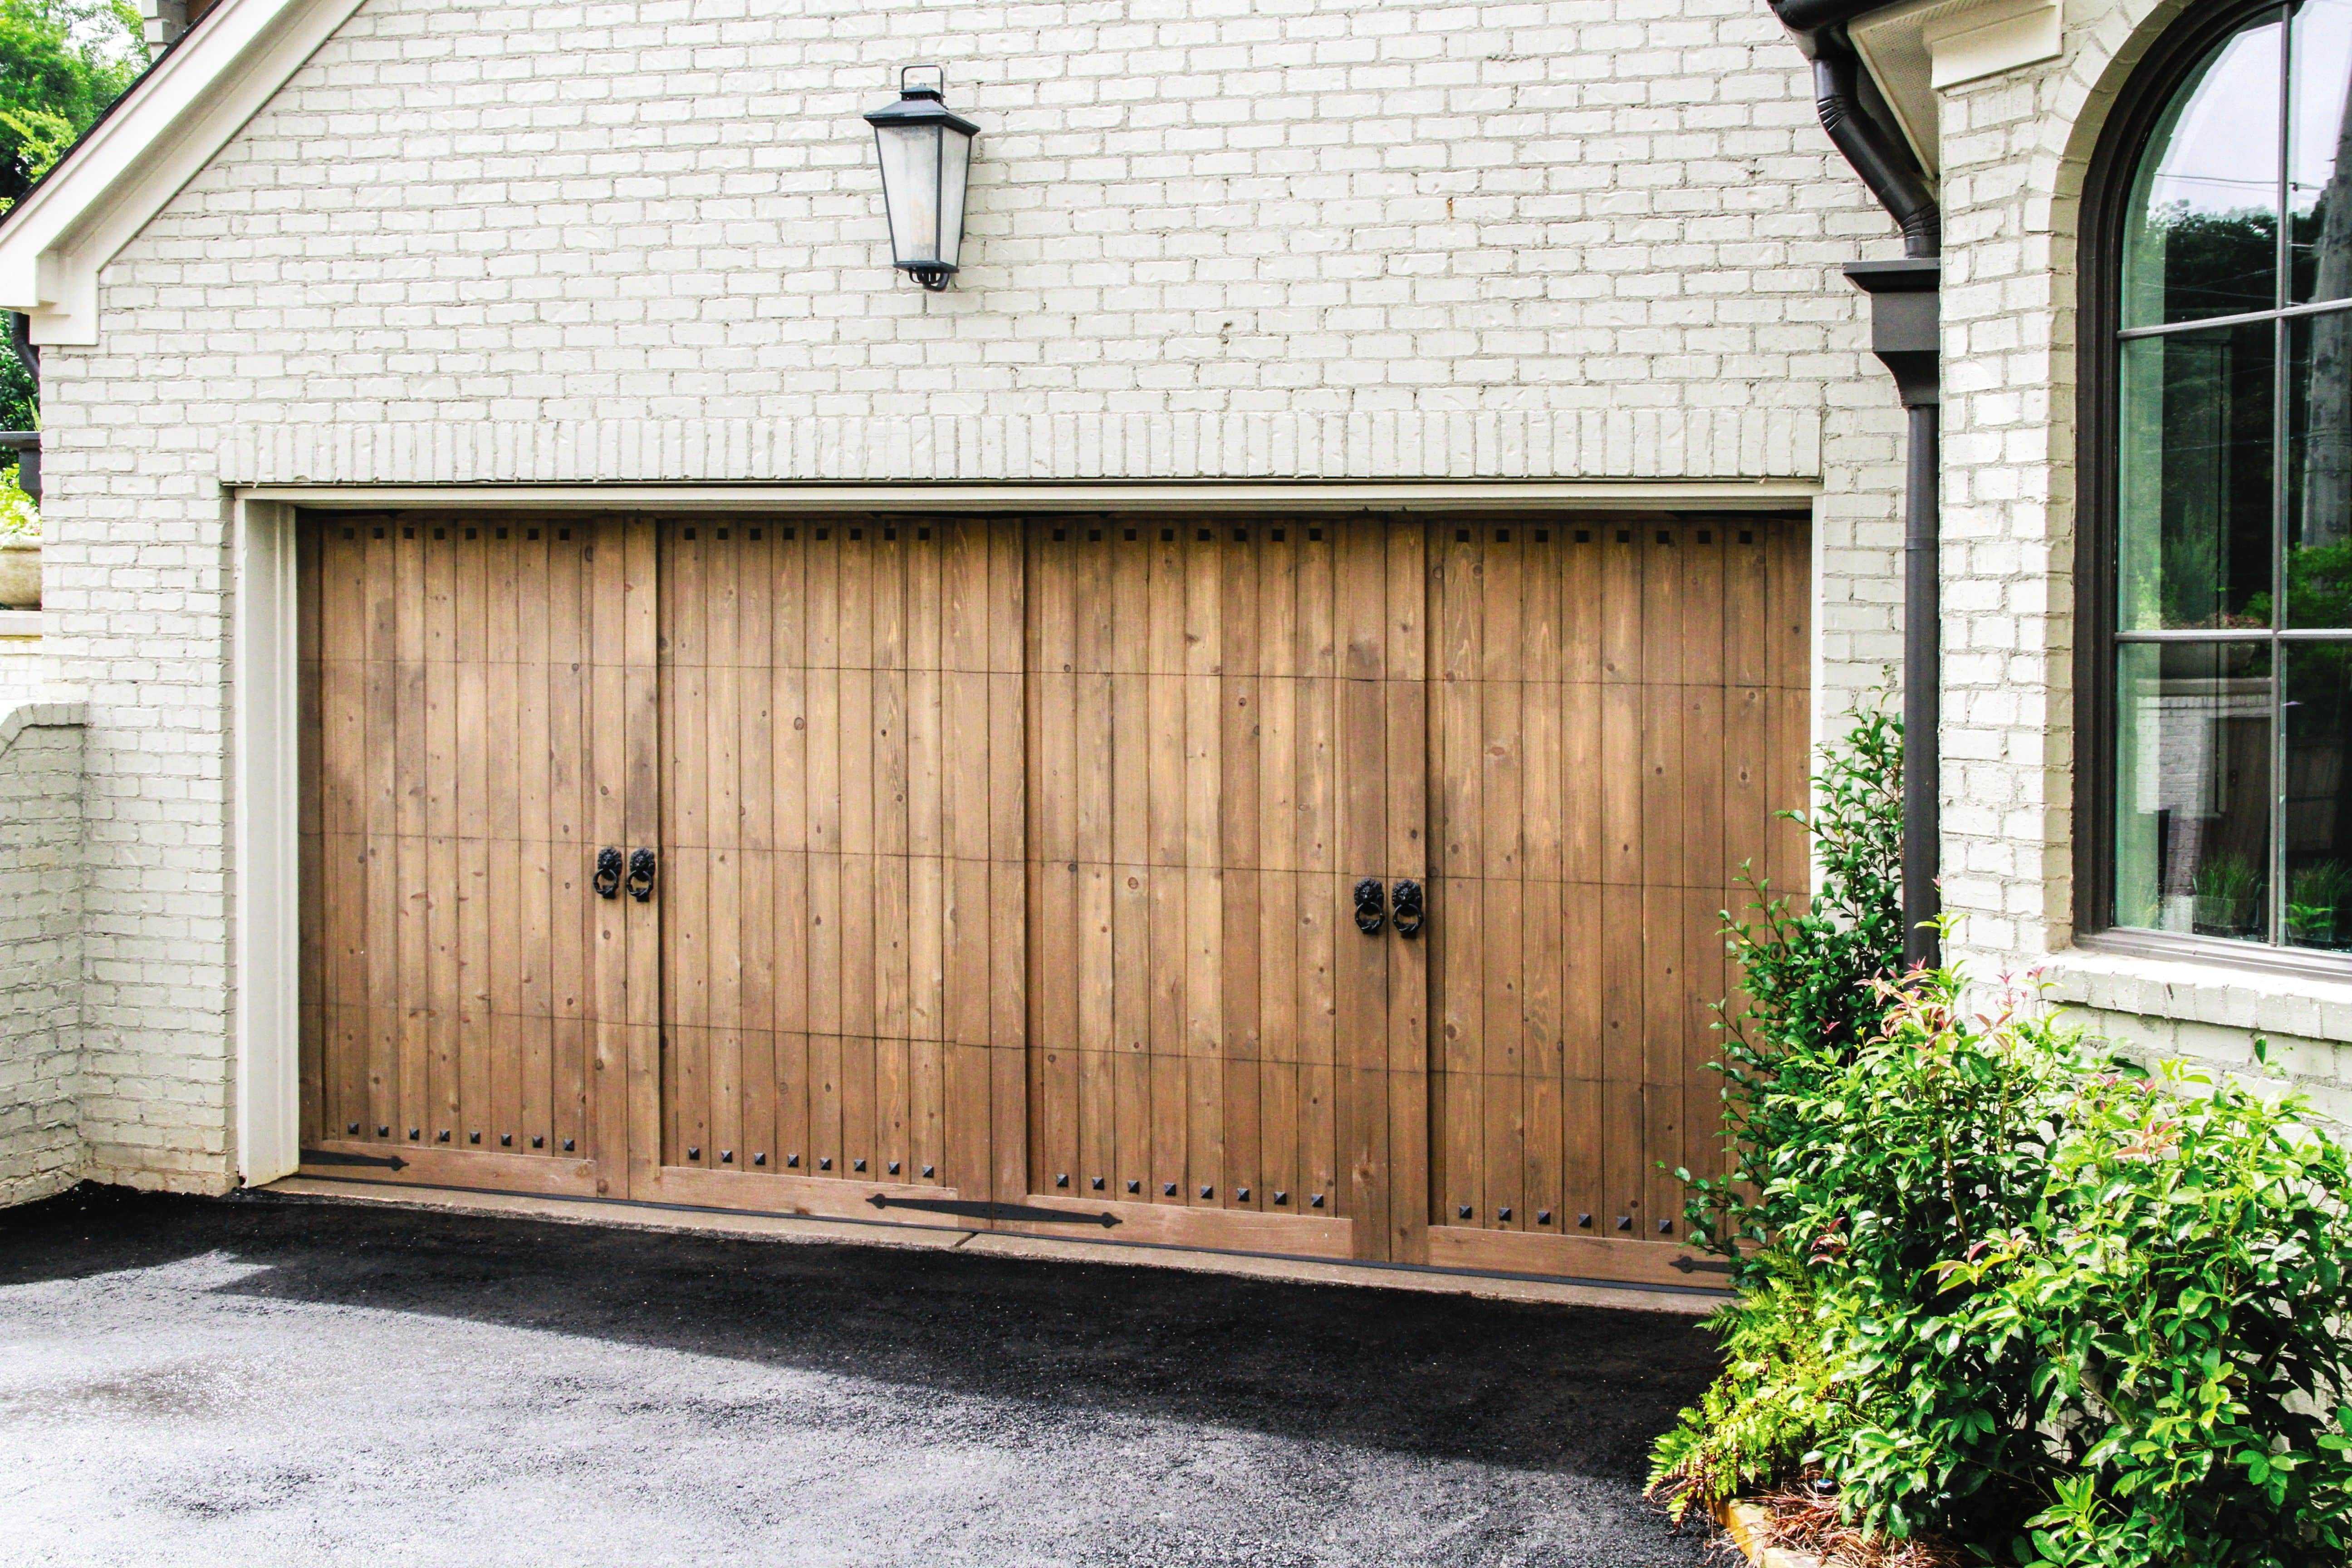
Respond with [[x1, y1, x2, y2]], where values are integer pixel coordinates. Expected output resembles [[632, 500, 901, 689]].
[[2114, 642, 2272, 941]]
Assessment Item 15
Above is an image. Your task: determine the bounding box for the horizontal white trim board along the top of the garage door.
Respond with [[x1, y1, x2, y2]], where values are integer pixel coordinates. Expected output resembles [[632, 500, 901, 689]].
[[238, 480, 1820, 513]]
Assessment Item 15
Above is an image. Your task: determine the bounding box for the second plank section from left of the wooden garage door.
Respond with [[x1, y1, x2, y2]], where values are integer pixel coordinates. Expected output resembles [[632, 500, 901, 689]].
[[649, 517, 1028, 1206]]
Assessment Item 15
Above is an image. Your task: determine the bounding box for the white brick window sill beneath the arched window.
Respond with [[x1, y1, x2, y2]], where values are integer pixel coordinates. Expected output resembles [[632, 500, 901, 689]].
[[2042, 931, 2352, 1044]]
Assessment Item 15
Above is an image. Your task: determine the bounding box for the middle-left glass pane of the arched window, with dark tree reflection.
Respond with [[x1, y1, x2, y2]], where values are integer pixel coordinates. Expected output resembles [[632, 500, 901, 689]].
[[2117, 322, 2277, 630]]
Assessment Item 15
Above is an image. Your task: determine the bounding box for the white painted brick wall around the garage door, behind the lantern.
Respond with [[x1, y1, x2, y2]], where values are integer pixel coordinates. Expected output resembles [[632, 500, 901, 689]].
[[44, 0, 1903, 1187]]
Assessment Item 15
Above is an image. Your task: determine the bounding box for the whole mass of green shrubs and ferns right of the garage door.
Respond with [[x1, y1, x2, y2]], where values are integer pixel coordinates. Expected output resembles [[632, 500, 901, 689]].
[[1653, 720, 2352, 1568]]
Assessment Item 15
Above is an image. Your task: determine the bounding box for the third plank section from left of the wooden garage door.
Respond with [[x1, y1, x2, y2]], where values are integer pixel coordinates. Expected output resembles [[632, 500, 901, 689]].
[[1028, 519, 1428, 1258]]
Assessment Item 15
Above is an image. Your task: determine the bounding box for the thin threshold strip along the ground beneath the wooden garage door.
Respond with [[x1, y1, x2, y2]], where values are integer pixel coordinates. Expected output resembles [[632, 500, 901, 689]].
[[259, 1176, 1731, 1317]]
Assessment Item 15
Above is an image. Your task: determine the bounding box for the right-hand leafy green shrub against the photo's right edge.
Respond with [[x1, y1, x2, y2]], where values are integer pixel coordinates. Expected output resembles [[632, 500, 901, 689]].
[[1947, 1048, 2352, 1568]]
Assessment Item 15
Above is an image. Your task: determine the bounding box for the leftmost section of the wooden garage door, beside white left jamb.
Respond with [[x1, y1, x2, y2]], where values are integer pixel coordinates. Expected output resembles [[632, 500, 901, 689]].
[[296, 517, 659, 1192]]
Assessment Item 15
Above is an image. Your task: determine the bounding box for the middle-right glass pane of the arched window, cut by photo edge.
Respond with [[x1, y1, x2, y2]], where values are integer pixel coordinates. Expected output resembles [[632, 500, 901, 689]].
[[2286, 310, 2352, 630]]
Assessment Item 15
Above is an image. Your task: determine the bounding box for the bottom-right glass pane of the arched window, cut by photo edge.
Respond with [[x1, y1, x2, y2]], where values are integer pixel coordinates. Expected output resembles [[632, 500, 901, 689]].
[[2286, 642, 2352, 947]]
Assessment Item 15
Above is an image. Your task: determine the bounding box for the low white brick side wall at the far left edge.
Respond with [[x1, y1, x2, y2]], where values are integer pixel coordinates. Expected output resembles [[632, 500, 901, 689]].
[[0, 703, 82, 1208]]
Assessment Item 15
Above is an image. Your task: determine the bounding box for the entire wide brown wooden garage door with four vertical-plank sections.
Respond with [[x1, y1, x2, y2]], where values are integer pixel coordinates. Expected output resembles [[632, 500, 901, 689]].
[[301, 515, 1808, 1279]]
